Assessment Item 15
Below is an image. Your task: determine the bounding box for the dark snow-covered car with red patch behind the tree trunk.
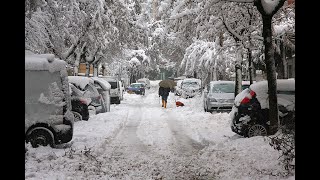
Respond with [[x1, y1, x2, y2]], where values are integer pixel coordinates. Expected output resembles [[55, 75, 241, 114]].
[[230, 79, 295, 137]]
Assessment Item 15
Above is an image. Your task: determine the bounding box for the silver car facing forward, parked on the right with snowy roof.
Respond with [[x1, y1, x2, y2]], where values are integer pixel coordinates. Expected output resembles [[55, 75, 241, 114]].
[[203, 81, 235, 112]]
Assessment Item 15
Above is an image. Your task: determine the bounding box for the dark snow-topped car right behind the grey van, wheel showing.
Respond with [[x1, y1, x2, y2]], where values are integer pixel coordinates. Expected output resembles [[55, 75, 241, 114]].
[[69, 83, 91, 121]]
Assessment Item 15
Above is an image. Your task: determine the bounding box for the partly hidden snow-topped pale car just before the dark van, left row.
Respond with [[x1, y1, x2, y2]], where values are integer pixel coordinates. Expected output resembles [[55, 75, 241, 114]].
[[91, 77, 111, 112]]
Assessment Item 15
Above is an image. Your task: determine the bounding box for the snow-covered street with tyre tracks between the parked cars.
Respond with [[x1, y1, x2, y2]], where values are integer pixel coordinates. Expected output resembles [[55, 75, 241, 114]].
[[25, 81, 295, 180]]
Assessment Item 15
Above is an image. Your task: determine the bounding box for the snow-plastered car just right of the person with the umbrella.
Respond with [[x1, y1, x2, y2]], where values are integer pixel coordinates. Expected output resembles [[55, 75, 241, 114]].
[[175, 78, 201, 98]]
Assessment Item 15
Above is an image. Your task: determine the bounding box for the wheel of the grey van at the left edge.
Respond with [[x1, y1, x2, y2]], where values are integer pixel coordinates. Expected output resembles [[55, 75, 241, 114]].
[[27, 127, 54, 148]]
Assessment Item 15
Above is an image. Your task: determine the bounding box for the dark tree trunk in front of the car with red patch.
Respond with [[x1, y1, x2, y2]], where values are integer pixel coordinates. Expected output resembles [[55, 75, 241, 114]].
[[262, 15, 278, 134]]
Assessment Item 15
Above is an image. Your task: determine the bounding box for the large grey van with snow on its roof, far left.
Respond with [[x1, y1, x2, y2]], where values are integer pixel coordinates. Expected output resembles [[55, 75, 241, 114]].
[[25, 51, 74, 147]]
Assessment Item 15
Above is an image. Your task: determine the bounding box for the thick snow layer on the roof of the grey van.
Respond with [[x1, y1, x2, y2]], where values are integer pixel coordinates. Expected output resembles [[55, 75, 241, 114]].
[[25, 53, 66, 73]]
